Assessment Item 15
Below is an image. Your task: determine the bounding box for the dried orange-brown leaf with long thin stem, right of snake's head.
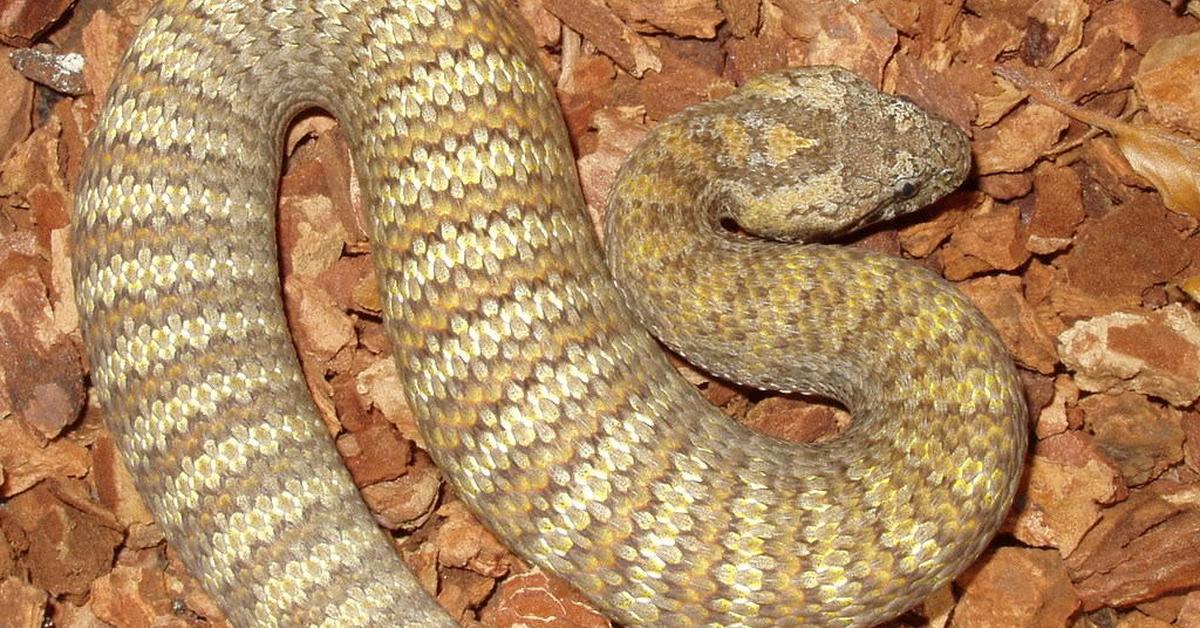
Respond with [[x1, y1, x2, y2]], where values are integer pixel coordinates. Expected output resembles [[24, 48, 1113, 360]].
[[996, 67, 1200, 217]]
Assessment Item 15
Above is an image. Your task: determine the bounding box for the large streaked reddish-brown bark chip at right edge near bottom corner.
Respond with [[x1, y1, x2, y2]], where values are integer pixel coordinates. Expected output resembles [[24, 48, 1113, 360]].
[[1067, 483, 1200, 610]]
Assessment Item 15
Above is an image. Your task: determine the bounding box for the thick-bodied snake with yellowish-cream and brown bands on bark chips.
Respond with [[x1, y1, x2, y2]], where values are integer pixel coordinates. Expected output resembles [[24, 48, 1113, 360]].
[[72, 0, 1027, 627]]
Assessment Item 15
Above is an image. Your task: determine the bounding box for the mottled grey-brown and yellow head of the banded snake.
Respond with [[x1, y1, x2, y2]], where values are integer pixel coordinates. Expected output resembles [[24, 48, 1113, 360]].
[[680, 67, 971, 241]]
